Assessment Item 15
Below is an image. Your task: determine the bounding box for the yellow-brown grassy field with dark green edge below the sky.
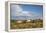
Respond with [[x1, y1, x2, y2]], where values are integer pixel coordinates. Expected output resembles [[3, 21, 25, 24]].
[[10, 19, 43, 29]]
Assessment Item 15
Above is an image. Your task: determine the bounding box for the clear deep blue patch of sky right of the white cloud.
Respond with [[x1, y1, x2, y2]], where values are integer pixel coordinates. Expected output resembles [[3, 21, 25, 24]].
[[21, 5, 43, 15]]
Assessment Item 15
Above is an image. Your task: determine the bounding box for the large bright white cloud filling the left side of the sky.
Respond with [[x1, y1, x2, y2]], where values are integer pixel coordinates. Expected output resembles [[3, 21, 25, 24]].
[[12, 5, 31, 16]]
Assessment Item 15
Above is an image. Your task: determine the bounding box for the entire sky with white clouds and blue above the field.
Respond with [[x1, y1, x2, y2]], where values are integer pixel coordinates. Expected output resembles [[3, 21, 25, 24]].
[[10, 4, 43, 20]]
